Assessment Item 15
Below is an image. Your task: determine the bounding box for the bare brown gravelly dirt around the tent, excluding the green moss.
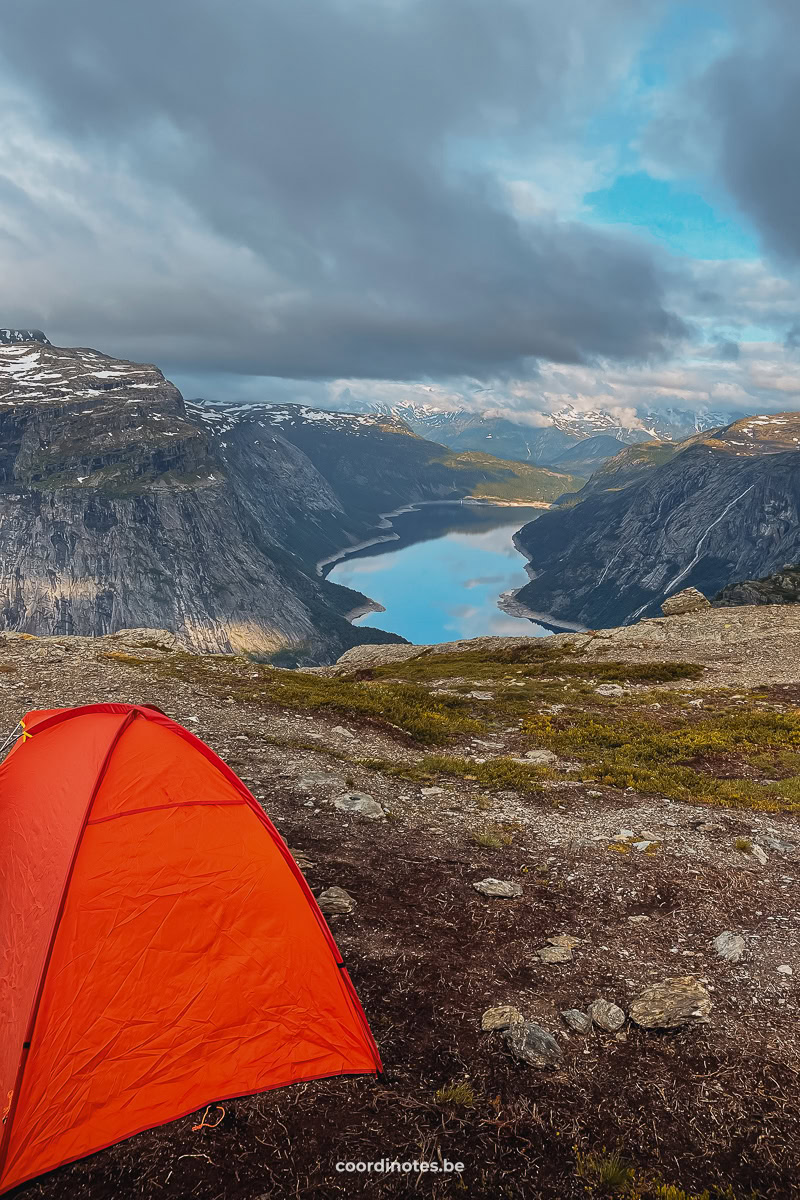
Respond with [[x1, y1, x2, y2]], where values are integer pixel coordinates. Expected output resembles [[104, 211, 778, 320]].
[[0, 628, 800, 1200]]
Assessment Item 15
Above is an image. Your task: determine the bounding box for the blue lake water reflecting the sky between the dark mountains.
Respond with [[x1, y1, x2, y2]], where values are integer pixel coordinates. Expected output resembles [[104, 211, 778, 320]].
[[329, 503, 551, 643]]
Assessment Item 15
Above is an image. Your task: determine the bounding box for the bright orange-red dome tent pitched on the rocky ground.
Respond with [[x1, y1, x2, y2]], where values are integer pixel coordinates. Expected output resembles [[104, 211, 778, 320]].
[[0, 704, 381, 1193]]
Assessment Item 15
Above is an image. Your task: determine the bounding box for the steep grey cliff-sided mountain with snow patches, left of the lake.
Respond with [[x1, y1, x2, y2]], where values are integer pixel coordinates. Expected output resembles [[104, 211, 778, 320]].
[[0, 330, 577, 662]]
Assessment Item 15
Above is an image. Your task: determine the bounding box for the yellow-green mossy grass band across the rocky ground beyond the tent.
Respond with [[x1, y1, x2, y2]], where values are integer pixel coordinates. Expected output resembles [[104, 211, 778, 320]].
[[115, 638, 800, 812]]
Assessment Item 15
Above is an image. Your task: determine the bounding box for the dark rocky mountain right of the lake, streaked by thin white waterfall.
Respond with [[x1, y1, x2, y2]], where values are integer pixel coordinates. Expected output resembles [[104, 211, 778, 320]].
[[513, 413, 800, 628]]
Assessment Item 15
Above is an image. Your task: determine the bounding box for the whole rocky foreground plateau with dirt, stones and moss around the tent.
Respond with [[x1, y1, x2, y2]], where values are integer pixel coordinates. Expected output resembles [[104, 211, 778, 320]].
[[0, 607, 800, 1200]]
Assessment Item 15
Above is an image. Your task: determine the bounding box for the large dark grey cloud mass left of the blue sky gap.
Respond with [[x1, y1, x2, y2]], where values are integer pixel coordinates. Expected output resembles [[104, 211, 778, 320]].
[[0, 0, 686, 379]]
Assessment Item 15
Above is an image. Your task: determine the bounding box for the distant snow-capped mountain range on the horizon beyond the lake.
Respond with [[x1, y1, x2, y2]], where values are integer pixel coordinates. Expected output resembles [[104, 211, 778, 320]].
[[326, 390, 733, 470]]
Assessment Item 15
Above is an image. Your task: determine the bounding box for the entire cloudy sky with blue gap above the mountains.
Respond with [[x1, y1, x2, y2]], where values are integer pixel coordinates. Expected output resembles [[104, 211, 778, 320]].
[[0, 0, 800, 422]]
